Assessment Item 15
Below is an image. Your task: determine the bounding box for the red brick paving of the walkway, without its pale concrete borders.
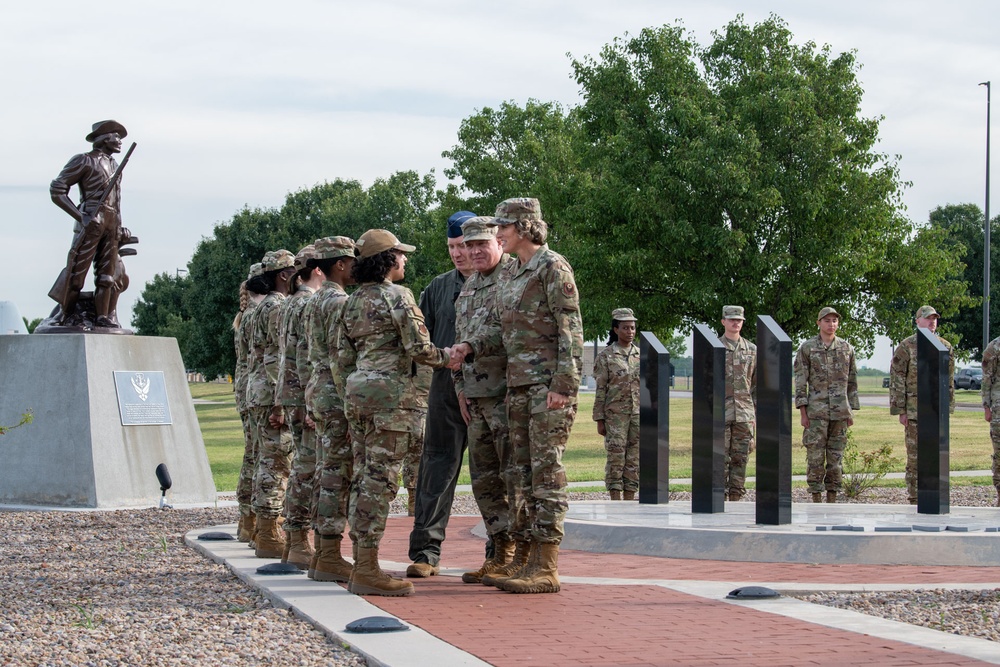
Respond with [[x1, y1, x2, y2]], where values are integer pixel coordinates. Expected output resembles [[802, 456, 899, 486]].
[[352, 517, 1000, 667]]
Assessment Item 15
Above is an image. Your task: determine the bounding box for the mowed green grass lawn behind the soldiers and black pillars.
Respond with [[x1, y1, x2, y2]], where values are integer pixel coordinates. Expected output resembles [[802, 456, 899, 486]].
[[190, 383, 993, 491]]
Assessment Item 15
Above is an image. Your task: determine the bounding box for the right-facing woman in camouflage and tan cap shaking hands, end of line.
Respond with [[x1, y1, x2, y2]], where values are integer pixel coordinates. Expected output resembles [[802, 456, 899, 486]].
[[334, 229, 449, 595]]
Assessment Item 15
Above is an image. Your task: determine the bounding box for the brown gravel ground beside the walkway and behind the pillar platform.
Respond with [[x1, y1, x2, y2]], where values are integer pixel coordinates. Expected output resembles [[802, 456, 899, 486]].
[[0, 487, 1000, 667]]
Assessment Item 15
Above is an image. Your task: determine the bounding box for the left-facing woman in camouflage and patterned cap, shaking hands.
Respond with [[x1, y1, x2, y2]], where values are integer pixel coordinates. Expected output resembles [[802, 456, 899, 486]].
[[455, 198, 583, 593]]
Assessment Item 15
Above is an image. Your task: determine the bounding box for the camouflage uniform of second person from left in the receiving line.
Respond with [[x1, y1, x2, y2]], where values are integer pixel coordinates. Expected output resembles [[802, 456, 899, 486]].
[[247, 251, 292, 519]]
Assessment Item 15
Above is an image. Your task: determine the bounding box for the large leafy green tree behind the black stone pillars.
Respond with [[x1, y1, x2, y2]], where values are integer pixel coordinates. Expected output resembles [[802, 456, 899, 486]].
[[445, 16, 963, 353]]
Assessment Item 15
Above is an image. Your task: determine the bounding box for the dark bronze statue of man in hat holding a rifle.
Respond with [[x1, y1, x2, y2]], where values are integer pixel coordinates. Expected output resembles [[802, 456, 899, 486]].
[[36, 120, 138, 333]]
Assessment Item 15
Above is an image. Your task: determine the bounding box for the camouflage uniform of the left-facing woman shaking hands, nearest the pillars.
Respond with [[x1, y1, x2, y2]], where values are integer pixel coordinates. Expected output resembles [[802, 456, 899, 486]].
[[464, 243, 583, 544]]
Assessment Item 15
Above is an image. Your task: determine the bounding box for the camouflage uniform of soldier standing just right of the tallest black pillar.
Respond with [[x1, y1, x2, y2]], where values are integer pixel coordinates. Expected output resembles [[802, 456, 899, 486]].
[[795, 336, 861, 493]]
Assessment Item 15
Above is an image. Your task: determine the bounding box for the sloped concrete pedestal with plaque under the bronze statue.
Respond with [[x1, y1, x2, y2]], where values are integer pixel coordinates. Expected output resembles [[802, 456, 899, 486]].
[[0, 334, 216, 508]]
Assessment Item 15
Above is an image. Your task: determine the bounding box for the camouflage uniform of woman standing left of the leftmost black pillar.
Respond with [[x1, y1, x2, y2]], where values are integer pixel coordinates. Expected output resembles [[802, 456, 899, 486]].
[[594, 342, 639, 492]]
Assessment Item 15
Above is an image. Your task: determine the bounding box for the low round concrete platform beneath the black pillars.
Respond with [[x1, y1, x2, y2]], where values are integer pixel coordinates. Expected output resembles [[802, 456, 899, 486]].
[[562, 500, 1000, 567]]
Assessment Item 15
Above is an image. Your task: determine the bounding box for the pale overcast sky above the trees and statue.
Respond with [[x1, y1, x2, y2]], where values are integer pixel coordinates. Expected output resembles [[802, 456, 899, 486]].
[[0, 0, 1000, 367]]
